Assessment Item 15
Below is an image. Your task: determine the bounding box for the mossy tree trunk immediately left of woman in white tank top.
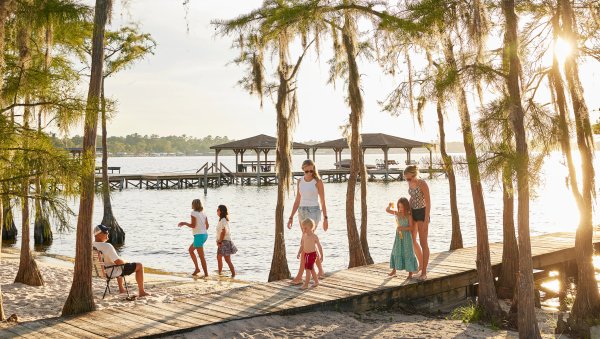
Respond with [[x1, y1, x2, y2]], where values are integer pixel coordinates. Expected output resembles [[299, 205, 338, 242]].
[[269, 33, 294, 281]]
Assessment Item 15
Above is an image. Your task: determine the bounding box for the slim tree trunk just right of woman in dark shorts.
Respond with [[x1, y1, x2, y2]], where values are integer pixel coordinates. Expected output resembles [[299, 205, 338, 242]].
[[436, 99, 463, 251]]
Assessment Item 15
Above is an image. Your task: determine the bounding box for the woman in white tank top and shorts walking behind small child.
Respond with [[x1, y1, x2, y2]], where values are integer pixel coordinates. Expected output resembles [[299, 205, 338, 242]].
[[287, 159, 329, 285]]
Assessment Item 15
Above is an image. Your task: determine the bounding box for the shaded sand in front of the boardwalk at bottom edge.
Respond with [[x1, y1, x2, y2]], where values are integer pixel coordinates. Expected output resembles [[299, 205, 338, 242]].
[[163, 312, 564, 339]]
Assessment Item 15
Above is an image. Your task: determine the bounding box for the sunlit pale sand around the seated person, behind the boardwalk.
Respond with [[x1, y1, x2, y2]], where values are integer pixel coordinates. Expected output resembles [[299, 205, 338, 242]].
[[0, 253, 247, 327]]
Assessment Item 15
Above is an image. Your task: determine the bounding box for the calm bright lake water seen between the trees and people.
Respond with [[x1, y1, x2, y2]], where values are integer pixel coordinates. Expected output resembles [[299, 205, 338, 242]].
[[5, 154, 600, 281]]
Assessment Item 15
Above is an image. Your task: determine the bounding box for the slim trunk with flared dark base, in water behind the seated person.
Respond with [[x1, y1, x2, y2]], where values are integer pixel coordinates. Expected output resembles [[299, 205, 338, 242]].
[[100, 78, 125, 246]]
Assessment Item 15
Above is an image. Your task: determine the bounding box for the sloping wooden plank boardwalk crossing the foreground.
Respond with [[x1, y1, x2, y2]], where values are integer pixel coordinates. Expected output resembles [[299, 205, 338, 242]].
[[0, 233, 600, 338]]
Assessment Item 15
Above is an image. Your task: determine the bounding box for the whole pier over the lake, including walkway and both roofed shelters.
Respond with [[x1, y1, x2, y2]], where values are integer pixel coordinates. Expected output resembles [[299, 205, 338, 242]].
[[96, 133, 445, 192]]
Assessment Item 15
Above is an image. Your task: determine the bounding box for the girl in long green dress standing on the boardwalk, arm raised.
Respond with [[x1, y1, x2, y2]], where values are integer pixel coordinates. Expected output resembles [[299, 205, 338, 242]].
[[386, 198, 419, 279]]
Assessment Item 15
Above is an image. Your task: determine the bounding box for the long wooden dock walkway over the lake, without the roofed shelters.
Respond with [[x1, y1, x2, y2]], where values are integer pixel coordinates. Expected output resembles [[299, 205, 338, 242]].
[[96, 169, 444, 190]]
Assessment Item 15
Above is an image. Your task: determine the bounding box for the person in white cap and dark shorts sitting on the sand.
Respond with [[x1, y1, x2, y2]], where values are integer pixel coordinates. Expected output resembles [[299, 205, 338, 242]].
[[92, 225, 150, 297]]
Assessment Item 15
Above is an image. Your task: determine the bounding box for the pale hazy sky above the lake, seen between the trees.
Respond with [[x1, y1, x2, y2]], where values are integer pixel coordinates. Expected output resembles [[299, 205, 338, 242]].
[[91, 0, 598, 142]]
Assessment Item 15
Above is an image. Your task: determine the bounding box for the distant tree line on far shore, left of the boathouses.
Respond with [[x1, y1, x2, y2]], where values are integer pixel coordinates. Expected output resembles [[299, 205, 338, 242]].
[[53, 133, 231, 155]]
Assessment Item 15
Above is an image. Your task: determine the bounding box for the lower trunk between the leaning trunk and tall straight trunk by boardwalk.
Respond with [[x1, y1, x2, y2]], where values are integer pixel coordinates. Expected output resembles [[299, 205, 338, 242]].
[[498, 164, 519, 299]]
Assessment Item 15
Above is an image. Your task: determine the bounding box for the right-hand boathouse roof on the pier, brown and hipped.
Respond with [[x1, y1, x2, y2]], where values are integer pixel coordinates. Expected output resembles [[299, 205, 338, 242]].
[[312, 133, 434, 149]]
